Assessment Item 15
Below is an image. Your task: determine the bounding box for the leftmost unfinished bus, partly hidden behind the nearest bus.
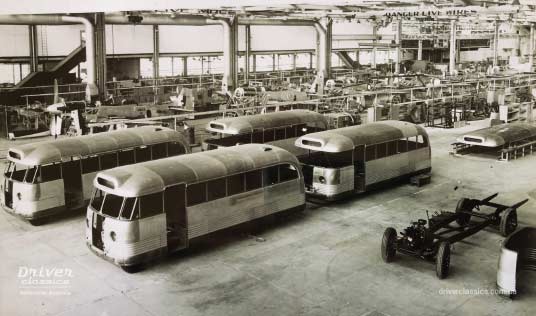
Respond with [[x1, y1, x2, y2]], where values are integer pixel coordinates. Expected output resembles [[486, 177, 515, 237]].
[[0, 126, 190, 225]]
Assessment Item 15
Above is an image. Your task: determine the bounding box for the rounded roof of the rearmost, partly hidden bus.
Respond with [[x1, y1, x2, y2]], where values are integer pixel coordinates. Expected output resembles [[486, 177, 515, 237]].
[[206, 110, 327, 135]]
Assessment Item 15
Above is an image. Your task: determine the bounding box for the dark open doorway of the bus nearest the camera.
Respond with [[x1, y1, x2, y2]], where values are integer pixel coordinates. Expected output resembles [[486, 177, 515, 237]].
[[164, 184, 188, 251]]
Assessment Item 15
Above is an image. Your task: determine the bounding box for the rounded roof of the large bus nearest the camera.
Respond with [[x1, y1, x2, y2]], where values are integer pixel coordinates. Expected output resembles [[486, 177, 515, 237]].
[[93, 144, 299, 197]]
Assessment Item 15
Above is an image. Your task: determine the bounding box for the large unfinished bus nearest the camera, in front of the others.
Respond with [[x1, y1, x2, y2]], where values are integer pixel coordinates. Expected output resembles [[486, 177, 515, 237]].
[[86, 144, 305, 273]]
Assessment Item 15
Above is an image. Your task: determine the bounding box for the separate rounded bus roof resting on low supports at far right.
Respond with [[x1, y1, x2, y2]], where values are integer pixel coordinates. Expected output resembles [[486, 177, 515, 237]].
[[456, 123, 536, 147]]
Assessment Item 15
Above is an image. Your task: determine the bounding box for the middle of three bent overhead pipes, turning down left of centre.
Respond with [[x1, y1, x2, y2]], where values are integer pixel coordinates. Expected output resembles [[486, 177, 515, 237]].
[[105, 14, 236, 92]]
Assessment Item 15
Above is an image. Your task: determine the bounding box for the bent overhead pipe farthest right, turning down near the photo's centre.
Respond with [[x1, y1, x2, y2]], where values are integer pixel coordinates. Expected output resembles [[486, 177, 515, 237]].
[[238, 17, 331, 86]]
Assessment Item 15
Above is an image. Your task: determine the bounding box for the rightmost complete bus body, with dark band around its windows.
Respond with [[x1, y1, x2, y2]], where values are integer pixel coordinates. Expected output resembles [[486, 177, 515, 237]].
[[296, 121, 431, 201]]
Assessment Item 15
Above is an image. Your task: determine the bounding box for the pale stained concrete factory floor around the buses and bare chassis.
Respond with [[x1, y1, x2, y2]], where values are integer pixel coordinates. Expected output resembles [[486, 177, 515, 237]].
[[0, 122, 536, 316]]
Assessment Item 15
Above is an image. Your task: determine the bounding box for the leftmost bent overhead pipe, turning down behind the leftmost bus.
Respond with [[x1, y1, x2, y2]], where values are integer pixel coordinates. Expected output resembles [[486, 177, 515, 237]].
[[0, 14, 99, 101]]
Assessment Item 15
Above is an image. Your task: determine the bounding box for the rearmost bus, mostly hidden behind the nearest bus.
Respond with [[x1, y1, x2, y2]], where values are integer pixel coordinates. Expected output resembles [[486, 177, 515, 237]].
[[203, 110, 328, 156]]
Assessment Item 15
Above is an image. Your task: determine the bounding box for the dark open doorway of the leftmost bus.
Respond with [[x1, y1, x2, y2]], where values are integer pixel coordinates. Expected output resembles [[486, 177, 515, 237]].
[[61, 160, 84, 209]]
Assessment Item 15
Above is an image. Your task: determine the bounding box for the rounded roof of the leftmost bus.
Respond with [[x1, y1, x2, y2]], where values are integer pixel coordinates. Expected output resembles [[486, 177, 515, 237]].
[[7, 126, 188, 166]]
